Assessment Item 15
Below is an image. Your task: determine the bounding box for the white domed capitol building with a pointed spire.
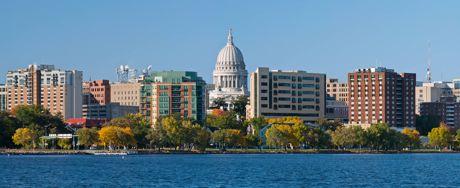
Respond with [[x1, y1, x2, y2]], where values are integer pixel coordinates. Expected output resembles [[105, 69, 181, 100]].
[[209, 30, 249, 108]]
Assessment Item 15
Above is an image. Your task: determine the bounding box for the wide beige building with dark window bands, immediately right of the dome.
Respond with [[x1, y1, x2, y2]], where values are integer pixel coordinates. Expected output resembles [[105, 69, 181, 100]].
[[247, 67, 326, 122]]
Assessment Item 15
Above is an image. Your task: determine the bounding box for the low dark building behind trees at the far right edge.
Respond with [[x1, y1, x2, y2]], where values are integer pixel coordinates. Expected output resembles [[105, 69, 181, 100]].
[[420, 96, 460, 128]]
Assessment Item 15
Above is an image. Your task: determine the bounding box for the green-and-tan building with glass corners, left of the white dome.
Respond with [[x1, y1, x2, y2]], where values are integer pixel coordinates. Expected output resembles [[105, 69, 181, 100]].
[[140, 71, 206, 125]]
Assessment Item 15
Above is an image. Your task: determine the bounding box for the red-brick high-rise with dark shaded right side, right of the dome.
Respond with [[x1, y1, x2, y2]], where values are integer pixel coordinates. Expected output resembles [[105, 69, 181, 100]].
[[348, 67, 416, 127]]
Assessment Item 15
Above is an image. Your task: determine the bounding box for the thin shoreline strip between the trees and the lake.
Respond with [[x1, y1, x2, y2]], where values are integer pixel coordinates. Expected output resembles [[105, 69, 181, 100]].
[[0, 149, 460, 155]]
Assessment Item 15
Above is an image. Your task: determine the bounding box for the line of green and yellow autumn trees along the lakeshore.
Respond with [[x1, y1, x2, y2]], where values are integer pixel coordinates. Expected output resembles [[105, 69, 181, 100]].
[[0, 105, 460, 154]]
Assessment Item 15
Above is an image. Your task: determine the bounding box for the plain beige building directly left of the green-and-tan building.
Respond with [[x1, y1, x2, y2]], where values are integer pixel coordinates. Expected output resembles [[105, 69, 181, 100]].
[[110, 82, 141, 107]]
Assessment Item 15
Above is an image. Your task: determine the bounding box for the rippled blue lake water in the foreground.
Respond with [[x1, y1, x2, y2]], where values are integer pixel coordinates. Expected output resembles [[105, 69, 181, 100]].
[[0, 154, 460, 187]]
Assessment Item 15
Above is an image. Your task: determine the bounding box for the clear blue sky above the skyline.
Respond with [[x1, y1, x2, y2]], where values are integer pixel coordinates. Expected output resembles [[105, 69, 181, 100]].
[[0, 0, 460, 83]]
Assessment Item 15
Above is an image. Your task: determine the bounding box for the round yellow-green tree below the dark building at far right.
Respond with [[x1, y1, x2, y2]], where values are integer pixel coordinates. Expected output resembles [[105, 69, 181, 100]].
[[428, 123, 452, 149]]
